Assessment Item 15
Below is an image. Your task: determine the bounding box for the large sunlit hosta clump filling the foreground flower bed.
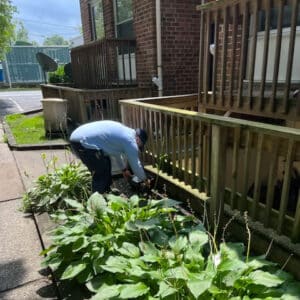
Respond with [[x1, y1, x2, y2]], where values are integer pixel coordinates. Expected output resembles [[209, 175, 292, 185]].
[[43, 193, 300, 300]]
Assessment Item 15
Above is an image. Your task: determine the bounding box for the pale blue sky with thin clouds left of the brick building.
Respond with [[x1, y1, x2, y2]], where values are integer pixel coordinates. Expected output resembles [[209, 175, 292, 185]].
[[11, 0, 81, 45]]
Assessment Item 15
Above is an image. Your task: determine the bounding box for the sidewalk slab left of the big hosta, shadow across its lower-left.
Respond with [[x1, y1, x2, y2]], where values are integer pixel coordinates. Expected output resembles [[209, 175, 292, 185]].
[[0, 200, 43, 292]]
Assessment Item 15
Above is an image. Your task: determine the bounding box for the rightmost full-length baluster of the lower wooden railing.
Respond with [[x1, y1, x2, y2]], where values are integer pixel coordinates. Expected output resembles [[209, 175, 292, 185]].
[[277, 139, 295, 234]]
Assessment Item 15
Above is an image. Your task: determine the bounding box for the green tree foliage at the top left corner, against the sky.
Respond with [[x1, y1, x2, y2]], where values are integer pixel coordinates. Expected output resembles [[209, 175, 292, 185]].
[[0, 0, 16, 59]]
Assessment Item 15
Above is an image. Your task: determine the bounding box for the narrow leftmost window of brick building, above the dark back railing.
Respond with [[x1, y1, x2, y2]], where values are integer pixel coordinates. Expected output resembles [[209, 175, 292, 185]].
[[90, 0, 105, 40]]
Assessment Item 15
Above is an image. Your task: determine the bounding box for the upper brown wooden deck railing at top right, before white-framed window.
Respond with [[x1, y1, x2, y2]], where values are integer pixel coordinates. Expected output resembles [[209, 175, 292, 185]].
[[198, 0, 300, 121]]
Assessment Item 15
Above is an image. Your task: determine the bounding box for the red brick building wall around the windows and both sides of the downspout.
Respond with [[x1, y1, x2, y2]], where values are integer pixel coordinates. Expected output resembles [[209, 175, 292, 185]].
[[80, 0, 200, 95]]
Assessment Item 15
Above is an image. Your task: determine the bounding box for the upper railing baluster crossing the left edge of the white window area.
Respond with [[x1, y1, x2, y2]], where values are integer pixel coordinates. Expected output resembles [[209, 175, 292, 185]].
[[248, 0, 258, 109]]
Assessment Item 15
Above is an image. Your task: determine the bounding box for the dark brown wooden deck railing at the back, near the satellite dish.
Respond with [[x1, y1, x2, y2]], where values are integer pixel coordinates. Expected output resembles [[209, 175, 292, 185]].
[[71, 39, 136, 89]]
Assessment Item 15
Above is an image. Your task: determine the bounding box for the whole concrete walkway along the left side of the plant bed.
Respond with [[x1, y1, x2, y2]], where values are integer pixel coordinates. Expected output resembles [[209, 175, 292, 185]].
[[0, 124, 71, 300]]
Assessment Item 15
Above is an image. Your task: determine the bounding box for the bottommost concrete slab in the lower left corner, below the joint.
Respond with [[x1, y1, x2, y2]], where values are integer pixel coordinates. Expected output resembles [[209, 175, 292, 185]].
[[0, 279, 58, 300]]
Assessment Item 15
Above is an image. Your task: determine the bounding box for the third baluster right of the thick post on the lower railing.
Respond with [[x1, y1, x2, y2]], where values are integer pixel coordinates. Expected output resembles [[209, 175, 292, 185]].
[[251, 133, 264, 219]]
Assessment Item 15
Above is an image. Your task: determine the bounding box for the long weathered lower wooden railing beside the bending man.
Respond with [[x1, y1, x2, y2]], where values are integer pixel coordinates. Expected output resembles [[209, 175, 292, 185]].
[[120, 96, 300, 242]]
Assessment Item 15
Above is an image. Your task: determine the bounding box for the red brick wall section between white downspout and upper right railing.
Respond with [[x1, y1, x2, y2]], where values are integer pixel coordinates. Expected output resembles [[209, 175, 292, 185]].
[[161, 0, 200, 95]]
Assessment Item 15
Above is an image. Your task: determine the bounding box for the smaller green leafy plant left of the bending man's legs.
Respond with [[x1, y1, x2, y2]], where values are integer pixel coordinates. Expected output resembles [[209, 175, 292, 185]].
[[23, 157, 91, 212]]
